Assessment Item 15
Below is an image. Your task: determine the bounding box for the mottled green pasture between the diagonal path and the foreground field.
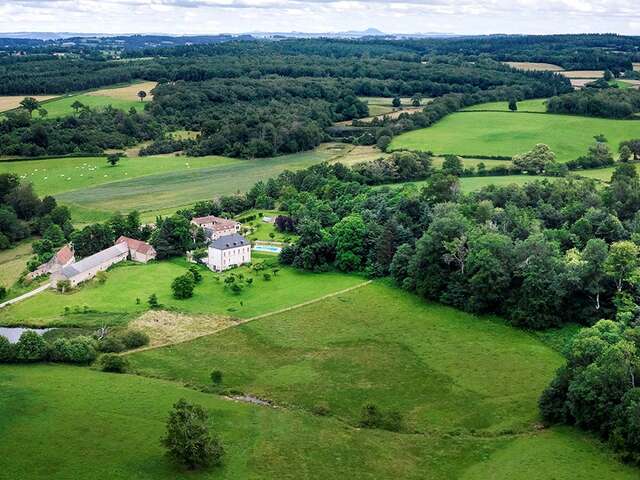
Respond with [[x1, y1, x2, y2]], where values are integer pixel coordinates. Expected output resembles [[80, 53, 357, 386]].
[[132, 283, 561, 433]]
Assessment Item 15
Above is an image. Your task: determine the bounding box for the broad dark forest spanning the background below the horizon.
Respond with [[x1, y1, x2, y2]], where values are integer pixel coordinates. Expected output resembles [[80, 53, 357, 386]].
[[0, 40, 571, 157]]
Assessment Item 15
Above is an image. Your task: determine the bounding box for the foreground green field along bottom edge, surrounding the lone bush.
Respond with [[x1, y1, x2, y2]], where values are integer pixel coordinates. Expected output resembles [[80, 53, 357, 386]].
[[0, 365, 637, 480]]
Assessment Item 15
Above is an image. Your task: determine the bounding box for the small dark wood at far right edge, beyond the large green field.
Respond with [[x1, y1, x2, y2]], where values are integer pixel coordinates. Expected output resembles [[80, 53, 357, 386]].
[[547, 88, 640, 119]]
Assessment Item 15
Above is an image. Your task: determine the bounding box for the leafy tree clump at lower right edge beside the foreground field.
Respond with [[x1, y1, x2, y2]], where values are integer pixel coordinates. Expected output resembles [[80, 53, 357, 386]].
[[540, 318, 640, 465]]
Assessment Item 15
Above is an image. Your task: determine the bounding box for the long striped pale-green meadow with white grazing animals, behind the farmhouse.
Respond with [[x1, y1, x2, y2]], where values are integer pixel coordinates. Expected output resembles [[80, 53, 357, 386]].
[[0, 144, 341, 224]]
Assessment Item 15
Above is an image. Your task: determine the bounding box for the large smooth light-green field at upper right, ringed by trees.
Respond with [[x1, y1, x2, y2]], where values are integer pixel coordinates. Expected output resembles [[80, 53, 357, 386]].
[[391, 112, 640, 161]]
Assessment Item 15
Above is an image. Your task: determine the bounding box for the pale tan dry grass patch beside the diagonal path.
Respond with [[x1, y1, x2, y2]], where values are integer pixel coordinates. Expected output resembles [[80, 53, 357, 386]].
[[129, 310, 237, 347]]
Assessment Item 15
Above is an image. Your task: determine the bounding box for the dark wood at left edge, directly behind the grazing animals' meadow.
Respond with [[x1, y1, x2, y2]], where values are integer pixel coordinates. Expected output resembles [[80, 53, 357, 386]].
[[0, 107, 163, 157]]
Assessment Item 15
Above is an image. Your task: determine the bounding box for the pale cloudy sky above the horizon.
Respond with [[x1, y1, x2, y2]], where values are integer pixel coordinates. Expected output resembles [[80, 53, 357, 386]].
[[0, 0, 640, 35]]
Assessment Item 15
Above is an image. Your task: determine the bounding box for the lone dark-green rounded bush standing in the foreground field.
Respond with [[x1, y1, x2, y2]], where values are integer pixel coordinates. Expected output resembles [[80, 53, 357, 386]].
[[162, 399, 224, 470]]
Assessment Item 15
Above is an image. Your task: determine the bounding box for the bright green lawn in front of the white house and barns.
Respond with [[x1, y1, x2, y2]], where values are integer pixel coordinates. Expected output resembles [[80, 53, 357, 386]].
[[0, 255, 364, 327]]
